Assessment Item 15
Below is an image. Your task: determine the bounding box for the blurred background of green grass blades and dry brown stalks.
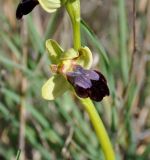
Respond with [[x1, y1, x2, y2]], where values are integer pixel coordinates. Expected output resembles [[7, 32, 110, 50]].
[[0, 0, 150, 160]]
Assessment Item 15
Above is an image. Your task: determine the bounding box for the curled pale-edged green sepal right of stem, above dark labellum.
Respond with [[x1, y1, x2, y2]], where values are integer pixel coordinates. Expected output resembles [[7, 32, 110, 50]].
[[77, 47, 93, 69]]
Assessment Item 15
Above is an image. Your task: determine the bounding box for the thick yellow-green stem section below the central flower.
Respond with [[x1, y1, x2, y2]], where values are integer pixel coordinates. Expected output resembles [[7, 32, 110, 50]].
[[80, 98, 115, 160]]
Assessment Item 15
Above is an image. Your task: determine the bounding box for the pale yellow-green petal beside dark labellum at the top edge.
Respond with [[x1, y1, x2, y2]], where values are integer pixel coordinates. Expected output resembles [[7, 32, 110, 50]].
[[38, 0, 61, 13]]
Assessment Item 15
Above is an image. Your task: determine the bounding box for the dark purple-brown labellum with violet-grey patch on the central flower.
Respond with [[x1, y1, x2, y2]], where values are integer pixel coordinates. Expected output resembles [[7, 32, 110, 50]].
[[67, 65, 109, 101]]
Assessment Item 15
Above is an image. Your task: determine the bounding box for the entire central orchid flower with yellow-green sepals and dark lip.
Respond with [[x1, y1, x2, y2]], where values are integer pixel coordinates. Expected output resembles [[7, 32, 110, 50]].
[[42, 40, 109, 101]]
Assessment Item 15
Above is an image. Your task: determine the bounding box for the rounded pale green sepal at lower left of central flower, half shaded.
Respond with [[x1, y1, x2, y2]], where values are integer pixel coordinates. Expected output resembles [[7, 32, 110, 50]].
[[42, 74, 69, 100]]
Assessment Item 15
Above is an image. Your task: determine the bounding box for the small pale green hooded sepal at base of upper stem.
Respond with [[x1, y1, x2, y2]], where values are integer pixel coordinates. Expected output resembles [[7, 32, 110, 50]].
[[60, 48, 79, 60]]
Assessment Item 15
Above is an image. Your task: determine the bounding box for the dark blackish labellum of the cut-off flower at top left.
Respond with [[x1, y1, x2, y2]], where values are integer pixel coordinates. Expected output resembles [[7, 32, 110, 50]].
[[16, 0, 39, 19]]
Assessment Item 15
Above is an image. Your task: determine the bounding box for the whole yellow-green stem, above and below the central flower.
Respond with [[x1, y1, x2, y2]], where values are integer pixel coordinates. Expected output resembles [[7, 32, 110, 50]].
[[66, 0, 115, 160]]
